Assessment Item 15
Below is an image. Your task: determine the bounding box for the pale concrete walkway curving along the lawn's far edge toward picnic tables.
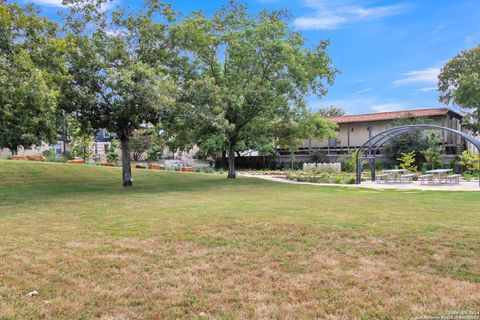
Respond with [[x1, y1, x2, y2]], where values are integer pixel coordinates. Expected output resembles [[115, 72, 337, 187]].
[[238, 174, 480, 192]]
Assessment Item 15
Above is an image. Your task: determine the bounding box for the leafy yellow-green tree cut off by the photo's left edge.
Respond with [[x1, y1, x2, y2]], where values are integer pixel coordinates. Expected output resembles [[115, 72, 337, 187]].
[[0, 3, 62, 154]]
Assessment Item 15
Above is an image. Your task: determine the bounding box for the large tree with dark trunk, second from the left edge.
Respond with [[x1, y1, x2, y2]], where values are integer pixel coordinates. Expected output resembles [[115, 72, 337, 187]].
[[62, 0, 177, 187]]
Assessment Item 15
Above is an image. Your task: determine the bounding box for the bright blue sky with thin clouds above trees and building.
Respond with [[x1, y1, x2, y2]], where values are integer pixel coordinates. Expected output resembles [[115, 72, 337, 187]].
[[16, 0, 480, 114]]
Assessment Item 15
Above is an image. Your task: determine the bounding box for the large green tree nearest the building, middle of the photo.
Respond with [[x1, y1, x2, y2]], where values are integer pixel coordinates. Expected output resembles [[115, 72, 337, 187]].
[[173, 1, 336, 178]]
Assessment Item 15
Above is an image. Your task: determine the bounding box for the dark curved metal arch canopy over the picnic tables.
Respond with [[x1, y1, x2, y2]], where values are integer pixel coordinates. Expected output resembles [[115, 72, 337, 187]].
[[356, 124, 480, 185]]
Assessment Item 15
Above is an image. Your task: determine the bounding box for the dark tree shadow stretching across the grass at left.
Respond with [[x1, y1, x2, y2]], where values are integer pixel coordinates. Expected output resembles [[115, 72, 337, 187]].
[[0, 172, 272, 211]]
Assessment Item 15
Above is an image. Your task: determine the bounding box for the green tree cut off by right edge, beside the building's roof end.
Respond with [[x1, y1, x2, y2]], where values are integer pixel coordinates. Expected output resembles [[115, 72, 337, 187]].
[[438, 45, 480, 134]]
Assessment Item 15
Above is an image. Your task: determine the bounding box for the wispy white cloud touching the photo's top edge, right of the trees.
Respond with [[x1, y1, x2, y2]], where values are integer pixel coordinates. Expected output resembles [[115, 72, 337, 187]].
[[294, 0, 406, 30]]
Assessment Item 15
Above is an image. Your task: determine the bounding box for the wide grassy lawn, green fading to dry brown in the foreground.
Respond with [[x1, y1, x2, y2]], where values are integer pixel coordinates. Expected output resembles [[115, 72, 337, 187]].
[[0, 161, 480, 319]]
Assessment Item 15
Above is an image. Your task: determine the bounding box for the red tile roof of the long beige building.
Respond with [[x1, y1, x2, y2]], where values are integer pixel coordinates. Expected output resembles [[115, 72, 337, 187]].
[[330, 108, 458, 123]]
